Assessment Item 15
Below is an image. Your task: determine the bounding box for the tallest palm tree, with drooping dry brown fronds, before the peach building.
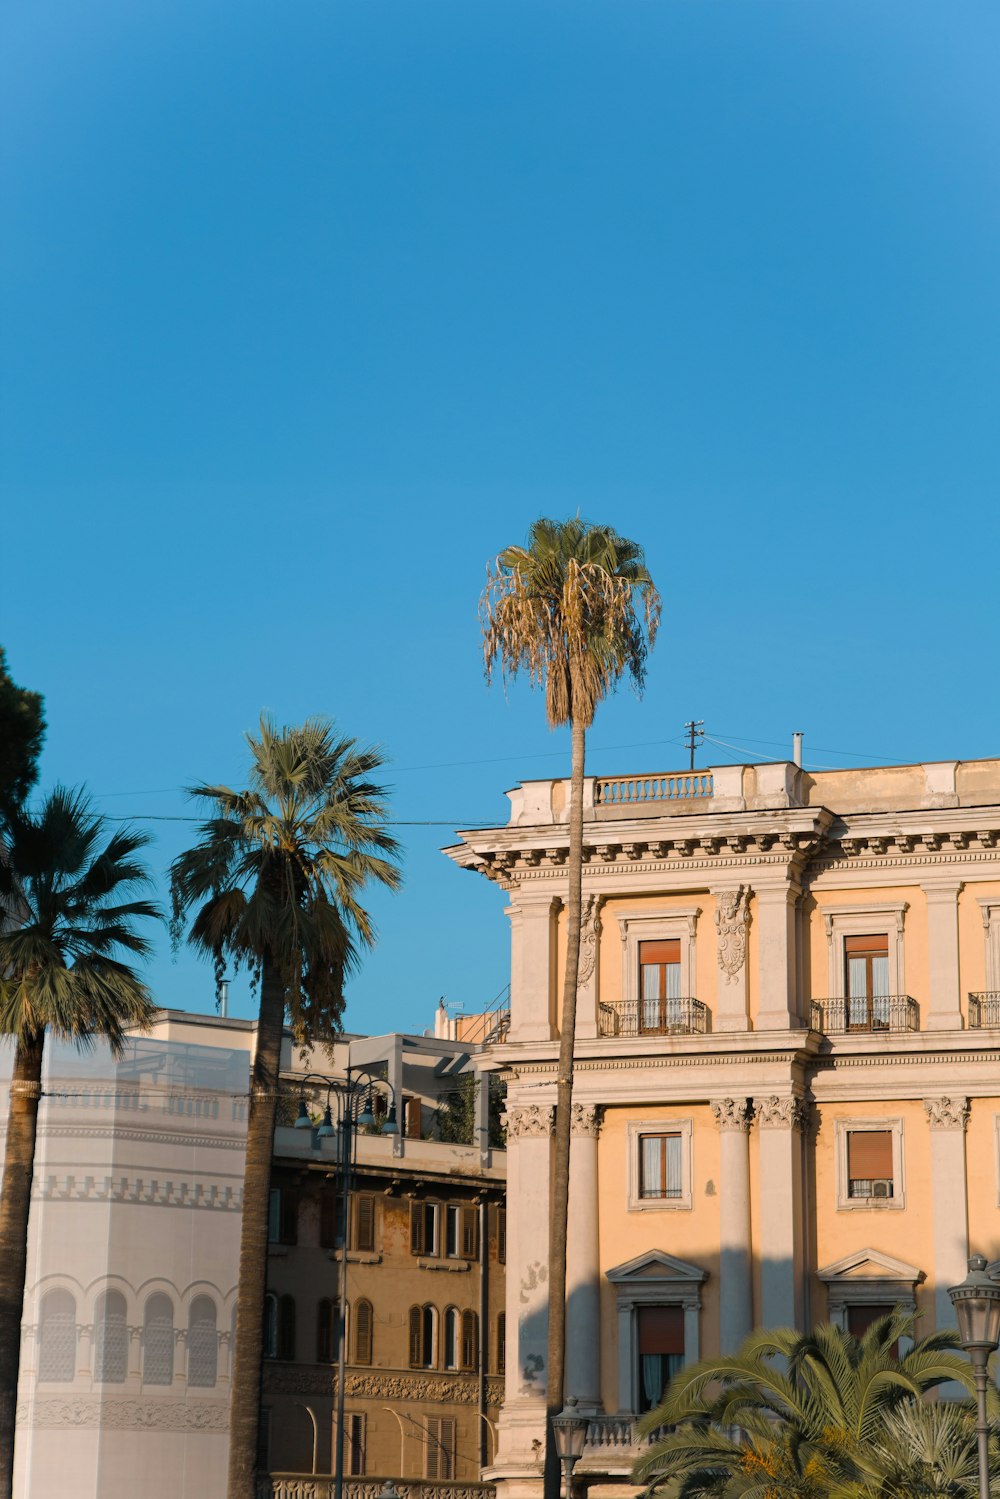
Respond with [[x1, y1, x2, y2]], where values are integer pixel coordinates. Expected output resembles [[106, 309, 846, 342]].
[[481, 516, 660, 1472]]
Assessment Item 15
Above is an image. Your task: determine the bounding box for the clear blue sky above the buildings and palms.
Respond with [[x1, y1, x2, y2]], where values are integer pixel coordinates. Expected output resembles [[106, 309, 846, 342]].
[[0, 0, 1000, 1030]]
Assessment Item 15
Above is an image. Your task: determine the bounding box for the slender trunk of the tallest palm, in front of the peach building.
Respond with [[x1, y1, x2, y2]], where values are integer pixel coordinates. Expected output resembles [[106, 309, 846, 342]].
[[546, 704, 586, 1499]]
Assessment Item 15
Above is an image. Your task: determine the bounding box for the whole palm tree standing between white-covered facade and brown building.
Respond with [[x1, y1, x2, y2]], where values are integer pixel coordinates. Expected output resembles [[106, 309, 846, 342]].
[[171, 715, 400, 1499]]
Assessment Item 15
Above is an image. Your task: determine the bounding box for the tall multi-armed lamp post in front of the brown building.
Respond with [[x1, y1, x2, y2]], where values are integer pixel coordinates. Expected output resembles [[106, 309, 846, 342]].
[[295, 1067, 399, 1499]]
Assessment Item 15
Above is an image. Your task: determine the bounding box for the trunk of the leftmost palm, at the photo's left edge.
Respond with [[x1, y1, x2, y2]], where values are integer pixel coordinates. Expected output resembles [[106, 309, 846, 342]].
[[0, 1030, 45, 1499]]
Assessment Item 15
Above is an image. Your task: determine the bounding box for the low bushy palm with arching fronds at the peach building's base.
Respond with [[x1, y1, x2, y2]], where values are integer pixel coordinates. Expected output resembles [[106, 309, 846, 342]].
[[636, 1307, 972, 1499]]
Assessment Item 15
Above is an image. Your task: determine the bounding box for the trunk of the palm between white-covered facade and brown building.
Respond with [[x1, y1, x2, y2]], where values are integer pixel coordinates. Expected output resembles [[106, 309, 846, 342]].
[[226, 961, 285, 1499]]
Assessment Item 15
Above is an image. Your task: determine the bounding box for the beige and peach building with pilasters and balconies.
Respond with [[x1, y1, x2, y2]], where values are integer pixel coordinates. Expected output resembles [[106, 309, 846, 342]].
[[448, 760, 1000, 1496]]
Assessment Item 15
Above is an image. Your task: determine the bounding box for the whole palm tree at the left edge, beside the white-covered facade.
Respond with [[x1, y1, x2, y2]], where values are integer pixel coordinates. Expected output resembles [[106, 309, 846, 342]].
[[0, 787, 160, 1499]]
